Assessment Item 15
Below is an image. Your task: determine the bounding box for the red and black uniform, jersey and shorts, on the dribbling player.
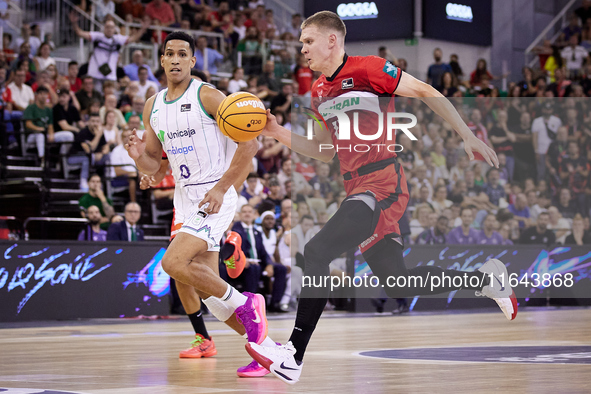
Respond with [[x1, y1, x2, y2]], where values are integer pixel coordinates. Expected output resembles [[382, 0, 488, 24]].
[[312, 55, 409, 253]]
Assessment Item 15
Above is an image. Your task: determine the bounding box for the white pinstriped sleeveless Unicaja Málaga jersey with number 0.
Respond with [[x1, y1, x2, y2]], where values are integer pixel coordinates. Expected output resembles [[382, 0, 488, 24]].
[[150, 79, 237, 188]]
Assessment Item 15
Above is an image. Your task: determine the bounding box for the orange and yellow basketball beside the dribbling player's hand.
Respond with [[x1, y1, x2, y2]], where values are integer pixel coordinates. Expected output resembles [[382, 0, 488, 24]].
[[217, 92, 267, 142]]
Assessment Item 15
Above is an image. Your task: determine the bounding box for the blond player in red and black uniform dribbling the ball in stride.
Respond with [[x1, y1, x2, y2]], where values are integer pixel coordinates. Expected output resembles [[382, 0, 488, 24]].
[[246, 11, 517, 384]]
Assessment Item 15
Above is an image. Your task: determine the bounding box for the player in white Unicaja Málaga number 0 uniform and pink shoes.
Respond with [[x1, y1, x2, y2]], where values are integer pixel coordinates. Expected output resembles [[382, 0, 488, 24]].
[[125, 31, 275, 366]]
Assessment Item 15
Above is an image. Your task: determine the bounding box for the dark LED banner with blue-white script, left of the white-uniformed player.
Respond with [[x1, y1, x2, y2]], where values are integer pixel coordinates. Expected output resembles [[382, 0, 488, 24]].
[[0, 241, 170, 322]]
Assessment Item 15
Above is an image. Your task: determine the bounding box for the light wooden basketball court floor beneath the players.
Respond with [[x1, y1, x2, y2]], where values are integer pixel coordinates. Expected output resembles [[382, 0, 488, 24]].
[[0, 308, 591, 394]]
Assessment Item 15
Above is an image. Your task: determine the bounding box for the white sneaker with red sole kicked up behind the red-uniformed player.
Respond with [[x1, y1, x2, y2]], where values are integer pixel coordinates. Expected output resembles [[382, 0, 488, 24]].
[[476, 259, 517, 320]]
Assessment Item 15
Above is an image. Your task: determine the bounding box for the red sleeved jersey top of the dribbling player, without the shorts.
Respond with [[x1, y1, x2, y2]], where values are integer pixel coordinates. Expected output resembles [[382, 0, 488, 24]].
[[312, 54, 402, 174]]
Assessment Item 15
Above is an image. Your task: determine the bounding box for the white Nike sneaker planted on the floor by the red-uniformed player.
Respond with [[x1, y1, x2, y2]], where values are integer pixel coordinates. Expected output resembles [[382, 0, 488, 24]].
[[246, 341, 304, 384]]
